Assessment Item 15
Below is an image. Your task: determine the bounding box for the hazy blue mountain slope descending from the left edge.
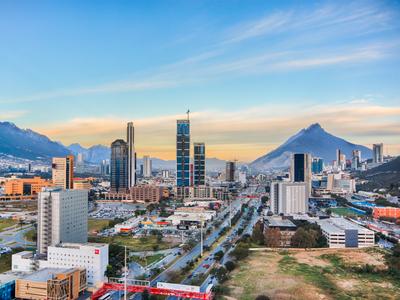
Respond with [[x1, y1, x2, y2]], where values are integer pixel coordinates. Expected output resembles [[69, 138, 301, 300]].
[[0, 122, 69, 160]]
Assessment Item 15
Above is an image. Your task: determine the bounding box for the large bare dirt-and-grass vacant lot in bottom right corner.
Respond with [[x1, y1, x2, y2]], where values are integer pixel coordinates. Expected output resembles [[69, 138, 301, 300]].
[[224, 249, 400, 300]]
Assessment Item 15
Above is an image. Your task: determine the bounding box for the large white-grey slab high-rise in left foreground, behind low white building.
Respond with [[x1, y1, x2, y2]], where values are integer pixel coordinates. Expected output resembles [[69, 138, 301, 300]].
[[37, 188, 88, 254]]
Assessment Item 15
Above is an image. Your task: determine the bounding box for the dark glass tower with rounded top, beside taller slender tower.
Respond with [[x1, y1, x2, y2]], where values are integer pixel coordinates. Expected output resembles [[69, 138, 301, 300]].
[[110, 139, 129, 193]]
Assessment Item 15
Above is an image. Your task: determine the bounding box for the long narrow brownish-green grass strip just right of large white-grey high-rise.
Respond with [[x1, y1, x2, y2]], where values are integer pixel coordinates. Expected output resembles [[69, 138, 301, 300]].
[[89, 235, 176, 251]]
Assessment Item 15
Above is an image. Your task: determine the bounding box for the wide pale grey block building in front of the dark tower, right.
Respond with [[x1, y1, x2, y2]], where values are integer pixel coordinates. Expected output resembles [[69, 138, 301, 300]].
[[270, 181, 309, 215]]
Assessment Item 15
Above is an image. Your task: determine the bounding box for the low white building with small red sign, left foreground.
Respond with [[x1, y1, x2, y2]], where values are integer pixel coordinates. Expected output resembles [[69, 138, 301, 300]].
[[12, 243, 108, 287]]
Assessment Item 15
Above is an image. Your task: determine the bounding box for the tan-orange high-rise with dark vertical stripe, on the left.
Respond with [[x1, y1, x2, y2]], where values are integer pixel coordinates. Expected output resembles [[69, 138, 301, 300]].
[[51, 155, 74, 190]]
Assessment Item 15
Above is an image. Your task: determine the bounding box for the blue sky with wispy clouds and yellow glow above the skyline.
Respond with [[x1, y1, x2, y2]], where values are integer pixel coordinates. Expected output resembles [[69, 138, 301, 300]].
[[0, 0, 400, 161]]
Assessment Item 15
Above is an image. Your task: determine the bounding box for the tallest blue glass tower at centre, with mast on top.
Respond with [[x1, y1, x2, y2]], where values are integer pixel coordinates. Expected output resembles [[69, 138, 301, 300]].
[[176, 119, 190, 187]]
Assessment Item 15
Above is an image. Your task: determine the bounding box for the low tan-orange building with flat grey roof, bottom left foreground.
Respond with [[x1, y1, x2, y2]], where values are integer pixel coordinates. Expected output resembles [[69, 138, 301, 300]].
[[15, 268, 87, 300]]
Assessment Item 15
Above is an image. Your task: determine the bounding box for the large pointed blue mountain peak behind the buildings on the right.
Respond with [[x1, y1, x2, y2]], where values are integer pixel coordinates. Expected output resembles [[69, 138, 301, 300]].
[[250, 123, 372, 170]]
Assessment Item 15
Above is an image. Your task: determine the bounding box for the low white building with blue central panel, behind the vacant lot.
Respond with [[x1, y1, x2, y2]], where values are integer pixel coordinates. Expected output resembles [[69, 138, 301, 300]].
[[317, 218, 375, 248]]
